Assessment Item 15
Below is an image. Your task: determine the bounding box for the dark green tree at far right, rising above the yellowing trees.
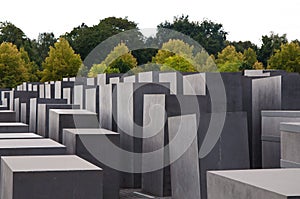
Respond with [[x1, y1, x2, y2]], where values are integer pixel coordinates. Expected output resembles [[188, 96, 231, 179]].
[[257, 32, 288, 68]]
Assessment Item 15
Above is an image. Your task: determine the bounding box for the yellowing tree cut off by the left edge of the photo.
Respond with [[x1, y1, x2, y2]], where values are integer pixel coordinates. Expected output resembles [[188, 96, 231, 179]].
[[0, 42, 28, 88]]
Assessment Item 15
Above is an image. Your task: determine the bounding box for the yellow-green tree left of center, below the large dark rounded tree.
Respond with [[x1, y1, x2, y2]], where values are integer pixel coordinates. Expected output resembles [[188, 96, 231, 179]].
[[88, 42, 137, 77]]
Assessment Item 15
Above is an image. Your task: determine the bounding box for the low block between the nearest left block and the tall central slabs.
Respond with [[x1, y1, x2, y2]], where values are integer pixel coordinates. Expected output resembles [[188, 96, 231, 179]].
[[63, 129, 120, 199]]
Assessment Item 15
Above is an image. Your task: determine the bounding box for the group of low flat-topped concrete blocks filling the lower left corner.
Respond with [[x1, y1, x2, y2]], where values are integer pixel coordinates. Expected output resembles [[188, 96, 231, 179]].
[[0, 112, 119, 199]]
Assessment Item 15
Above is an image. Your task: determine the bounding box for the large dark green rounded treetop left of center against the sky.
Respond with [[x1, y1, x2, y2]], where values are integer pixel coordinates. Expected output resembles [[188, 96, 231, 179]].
[[64, 17, 137, 59]]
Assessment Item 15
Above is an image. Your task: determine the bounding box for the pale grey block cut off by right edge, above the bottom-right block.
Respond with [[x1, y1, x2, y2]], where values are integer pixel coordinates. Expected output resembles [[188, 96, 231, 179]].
[[280, 122, 300, 168]]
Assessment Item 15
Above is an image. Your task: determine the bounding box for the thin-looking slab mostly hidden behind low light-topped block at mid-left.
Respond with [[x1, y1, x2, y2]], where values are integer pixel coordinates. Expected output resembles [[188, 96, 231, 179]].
[[37, 104, 79, 138]]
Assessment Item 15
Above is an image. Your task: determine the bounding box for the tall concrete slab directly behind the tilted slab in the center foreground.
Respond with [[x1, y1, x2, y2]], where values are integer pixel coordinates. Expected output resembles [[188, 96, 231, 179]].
[[142, 94, 210, 196]]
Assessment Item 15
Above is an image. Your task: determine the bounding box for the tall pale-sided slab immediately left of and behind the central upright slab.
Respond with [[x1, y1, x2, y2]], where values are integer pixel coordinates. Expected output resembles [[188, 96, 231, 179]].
[[117, 83, 170, 188]]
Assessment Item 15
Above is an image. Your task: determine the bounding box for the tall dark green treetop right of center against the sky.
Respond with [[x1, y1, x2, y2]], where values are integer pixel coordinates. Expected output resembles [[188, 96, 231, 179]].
[[158, 15, 228, 55]]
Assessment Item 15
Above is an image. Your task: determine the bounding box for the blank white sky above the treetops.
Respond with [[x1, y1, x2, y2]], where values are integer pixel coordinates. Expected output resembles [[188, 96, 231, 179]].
[[0, 0, 300, 44]]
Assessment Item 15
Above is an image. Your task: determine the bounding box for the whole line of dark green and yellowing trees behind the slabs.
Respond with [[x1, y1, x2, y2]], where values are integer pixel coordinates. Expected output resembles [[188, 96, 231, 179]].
[[0, 15, 300, 88]]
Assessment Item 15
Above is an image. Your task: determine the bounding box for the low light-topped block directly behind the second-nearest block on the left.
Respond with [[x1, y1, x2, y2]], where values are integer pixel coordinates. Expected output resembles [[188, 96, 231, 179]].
[[49, 109, 99, 143]]
